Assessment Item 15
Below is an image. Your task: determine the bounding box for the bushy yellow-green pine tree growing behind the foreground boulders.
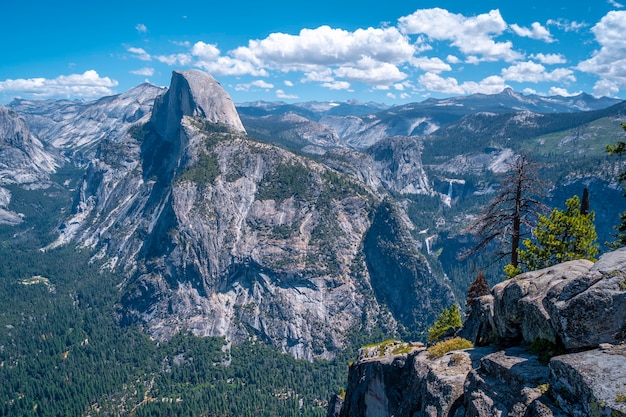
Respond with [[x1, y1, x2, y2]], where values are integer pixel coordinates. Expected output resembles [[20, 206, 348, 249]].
[[507, 196, 598, 275]]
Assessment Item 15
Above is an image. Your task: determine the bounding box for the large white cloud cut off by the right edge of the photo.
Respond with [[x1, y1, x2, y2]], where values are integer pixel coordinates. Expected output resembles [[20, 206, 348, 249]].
[[577, 11, 626, 95]]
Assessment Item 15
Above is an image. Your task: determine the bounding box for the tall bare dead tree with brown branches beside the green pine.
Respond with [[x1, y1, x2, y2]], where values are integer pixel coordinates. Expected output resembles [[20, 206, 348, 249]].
[[463, 155, 546, 267]]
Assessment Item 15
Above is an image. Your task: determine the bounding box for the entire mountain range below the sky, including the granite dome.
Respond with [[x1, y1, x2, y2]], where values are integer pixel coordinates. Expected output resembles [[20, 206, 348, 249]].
[[0, 70, 626, 360]]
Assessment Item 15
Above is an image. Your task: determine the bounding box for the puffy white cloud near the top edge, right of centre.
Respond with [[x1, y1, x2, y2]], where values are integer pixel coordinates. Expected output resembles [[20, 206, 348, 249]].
[[398, 8, 522, 62]]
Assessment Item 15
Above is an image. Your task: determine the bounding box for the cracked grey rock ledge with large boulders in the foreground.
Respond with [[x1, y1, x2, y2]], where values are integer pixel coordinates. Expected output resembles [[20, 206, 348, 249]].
[[329, 249, 626, 417]]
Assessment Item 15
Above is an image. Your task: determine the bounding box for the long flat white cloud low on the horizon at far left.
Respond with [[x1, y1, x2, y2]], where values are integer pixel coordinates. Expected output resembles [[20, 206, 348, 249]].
[[0, 70, 118, 99]]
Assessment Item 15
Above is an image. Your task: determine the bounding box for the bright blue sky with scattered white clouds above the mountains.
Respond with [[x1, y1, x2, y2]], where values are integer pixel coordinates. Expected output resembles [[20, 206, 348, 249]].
[[0, 0, 626, 104]]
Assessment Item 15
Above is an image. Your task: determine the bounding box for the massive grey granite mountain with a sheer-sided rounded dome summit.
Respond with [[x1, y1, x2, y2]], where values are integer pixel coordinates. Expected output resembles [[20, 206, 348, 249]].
[[41, 71, 453, 359]]
